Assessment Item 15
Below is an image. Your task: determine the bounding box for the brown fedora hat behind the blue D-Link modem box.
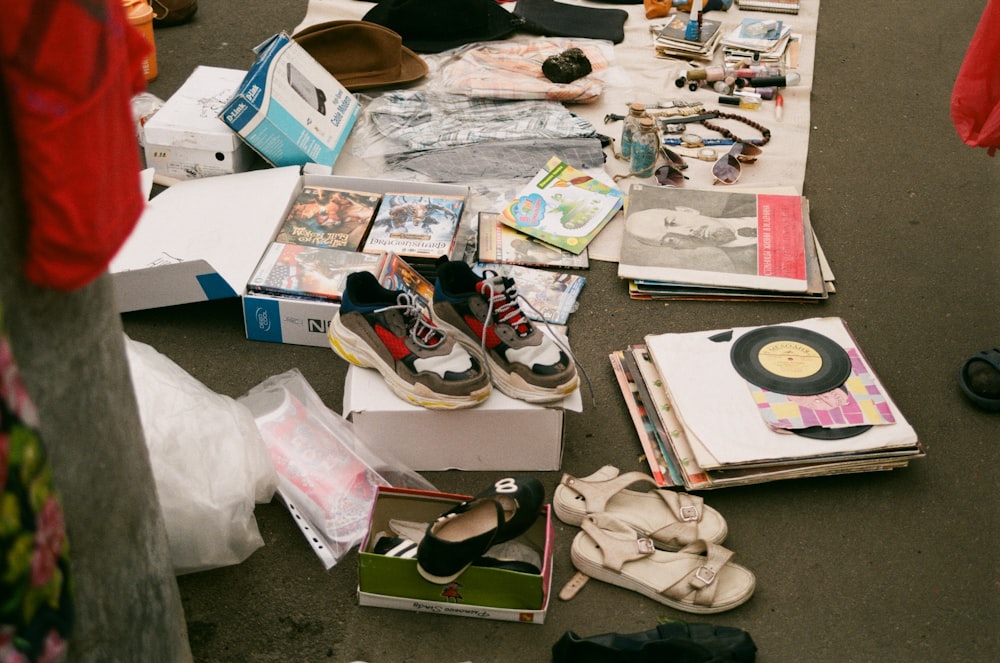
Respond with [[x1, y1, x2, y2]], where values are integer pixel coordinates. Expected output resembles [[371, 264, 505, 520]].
[[292, 21, 427, 92]]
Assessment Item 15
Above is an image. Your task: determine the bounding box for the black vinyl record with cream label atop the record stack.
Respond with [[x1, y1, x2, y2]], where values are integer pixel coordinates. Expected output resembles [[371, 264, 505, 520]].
[[729, 325, 851, 396]]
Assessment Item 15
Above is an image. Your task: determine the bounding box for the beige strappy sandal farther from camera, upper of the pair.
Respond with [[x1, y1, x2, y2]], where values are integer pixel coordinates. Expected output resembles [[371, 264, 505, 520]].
[[552, 465, 729, 550]]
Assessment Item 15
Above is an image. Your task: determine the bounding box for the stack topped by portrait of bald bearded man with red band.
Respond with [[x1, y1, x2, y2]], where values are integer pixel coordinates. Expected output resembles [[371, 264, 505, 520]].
[[618, 184, 834, 301]]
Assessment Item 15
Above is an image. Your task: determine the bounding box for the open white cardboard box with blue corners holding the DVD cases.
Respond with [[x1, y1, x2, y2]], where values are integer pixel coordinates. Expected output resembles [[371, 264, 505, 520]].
[[109, 169, 469, 324]]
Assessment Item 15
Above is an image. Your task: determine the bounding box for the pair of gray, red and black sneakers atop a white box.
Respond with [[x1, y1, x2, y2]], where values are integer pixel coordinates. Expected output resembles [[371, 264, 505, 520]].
[[328, 259, 579, 409]]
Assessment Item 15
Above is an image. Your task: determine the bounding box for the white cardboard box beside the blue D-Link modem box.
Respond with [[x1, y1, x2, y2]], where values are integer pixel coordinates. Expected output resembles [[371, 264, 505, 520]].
[[143, 66, 256, 180]]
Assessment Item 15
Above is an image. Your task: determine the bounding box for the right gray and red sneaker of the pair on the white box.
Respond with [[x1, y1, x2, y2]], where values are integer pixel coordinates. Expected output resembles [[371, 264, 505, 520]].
[[431, 260, 580, 403]]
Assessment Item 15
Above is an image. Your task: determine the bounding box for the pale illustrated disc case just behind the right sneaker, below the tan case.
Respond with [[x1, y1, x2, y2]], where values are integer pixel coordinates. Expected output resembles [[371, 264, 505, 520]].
[[474, 263, 587, 325]]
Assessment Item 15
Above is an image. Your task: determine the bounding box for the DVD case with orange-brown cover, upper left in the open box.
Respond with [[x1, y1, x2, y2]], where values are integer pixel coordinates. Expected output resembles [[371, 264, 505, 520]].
[[274, 186, 382, 251]]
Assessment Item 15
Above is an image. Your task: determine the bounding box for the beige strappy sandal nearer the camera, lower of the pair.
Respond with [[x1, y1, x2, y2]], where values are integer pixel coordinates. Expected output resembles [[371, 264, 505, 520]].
[[570, 514, 757, 614]]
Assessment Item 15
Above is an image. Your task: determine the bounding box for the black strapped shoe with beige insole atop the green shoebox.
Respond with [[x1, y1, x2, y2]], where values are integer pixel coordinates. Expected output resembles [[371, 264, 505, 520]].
[[417, 477, 545, 585]]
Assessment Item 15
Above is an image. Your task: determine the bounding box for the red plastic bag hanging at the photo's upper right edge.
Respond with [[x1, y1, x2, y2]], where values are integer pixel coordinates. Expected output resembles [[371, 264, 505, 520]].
[[951, 0, 1000, 156]]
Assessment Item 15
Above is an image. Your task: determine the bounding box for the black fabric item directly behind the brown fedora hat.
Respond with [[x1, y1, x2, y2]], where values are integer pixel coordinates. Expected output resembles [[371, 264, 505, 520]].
[[362, 0, 521, 53]]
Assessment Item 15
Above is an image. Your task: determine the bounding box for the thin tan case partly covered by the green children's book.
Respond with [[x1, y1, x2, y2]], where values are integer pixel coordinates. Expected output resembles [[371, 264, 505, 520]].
[[477, 212, 590, 269]]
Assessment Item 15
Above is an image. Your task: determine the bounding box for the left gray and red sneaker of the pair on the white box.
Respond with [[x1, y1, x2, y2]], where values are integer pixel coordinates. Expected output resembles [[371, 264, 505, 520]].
[[327, 272, 491, 410]]
